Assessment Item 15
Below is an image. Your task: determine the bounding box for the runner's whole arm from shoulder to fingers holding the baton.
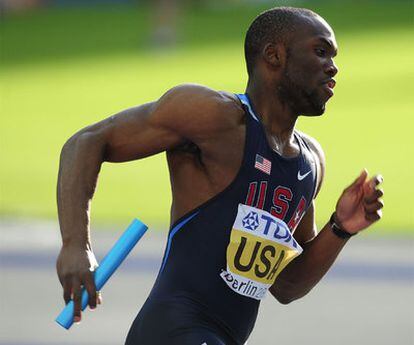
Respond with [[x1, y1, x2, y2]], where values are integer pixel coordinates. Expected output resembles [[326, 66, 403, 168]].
[[57, 85, 234, 322]]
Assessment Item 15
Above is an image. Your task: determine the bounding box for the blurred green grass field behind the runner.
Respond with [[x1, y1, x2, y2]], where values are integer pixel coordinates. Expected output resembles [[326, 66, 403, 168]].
[[0, 1, 414, 235]]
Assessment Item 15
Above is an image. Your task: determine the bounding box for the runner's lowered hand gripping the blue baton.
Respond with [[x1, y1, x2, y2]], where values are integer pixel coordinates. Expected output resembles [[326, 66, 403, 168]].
[[56, 245, 102, 322]]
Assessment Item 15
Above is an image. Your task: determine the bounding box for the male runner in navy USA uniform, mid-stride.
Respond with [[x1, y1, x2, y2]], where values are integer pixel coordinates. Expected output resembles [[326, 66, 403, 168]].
[[57, 8, 383, 345]]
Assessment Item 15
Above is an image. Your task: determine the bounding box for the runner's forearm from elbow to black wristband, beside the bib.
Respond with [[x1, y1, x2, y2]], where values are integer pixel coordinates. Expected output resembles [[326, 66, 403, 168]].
[[270, 223, 347, 304]]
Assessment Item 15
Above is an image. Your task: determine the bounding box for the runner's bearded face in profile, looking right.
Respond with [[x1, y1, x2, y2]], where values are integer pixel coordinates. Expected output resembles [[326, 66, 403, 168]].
[[278, 17, 338, 116]]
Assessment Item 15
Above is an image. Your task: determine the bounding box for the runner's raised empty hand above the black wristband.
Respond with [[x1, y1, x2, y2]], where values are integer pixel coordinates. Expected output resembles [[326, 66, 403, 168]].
[[336, 170, 384, 234]]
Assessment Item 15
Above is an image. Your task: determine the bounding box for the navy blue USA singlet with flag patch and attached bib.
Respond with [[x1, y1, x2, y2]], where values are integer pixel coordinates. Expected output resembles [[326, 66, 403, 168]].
[[126, 95, 317, 345]]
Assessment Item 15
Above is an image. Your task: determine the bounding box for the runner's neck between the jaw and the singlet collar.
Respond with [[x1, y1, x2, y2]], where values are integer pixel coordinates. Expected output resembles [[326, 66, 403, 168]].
[[246, 78, 298, 144]]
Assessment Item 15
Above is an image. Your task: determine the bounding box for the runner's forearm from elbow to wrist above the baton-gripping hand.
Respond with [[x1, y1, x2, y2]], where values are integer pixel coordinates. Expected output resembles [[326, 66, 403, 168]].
[[57, 132, 105, 247]]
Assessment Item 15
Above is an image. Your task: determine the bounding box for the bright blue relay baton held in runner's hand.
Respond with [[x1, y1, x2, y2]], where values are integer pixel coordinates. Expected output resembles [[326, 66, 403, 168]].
[[55, 219, 148, 329]]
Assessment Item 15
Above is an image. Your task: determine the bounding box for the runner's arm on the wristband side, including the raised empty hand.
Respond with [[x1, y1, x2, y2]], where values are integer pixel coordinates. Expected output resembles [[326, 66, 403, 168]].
[[270, 136, 383, 304]]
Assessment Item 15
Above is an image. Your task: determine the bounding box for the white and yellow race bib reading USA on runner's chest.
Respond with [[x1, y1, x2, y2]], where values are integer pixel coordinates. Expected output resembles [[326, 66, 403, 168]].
[[220, 204, 302, 300]]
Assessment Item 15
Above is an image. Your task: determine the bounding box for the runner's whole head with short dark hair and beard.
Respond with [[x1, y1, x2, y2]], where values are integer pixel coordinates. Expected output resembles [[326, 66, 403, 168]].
[[245, 7, 338, 115]]
